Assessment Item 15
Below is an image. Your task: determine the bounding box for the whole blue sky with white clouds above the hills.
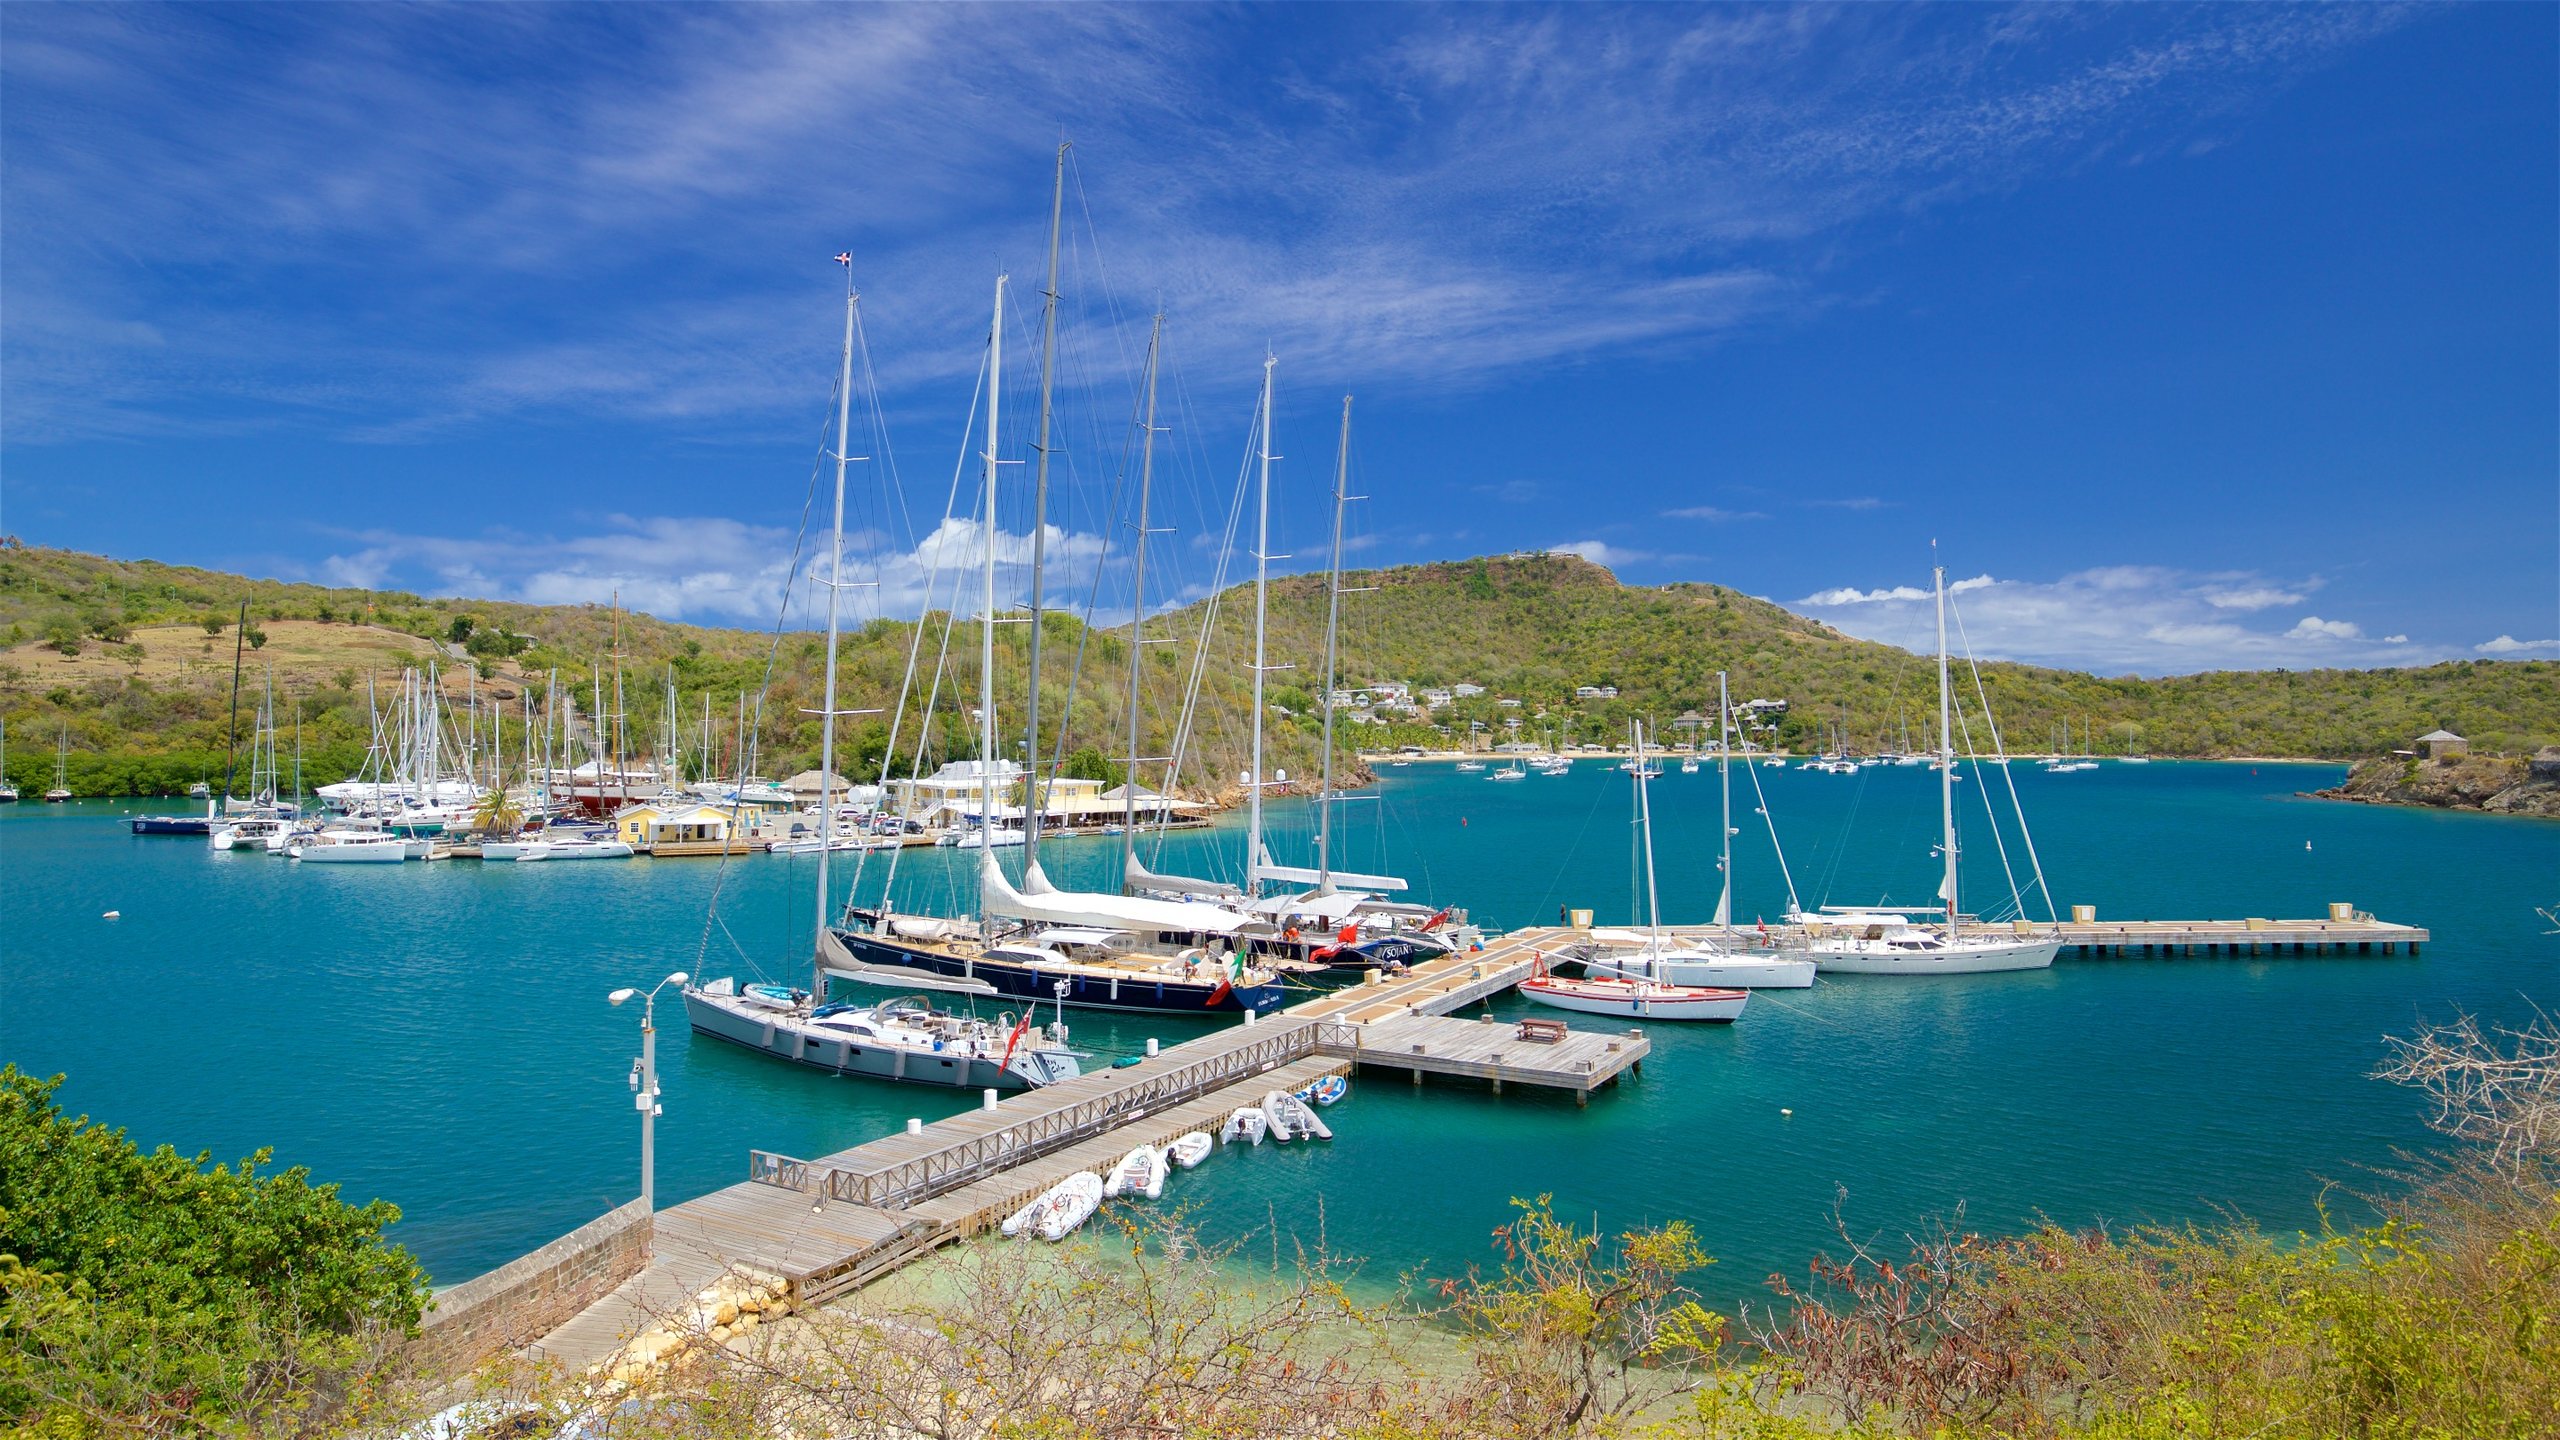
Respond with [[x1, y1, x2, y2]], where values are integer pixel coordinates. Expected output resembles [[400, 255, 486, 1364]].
[[0, 5, 2560, 671]]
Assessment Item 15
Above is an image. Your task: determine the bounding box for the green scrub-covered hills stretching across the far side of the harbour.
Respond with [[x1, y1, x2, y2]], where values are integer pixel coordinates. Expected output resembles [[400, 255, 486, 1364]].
[[0, 543, 2560, 794]]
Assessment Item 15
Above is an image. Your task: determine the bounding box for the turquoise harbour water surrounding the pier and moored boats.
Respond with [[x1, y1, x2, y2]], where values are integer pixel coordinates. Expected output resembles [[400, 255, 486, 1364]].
[[0, 761, 2560, 1302]]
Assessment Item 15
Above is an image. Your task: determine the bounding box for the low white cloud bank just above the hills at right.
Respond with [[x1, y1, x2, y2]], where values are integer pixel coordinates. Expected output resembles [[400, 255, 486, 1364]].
[[1792, 564, 2452, 674]]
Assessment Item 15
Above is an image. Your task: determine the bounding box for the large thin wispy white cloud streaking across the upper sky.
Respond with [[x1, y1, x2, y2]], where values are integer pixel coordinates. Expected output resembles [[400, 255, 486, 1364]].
[[0, 5, 2396, 438]]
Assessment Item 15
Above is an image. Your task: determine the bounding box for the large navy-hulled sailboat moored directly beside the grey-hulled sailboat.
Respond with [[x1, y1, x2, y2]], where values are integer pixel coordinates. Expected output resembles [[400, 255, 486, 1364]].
[[819, 254, 1280, 1012]]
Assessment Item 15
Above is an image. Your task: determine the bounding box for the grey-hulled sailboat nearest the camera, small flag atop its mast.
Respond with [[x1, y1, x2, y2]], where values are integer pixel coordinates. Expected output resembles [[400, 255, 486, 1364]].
[[684, 261, 1078, 1089]]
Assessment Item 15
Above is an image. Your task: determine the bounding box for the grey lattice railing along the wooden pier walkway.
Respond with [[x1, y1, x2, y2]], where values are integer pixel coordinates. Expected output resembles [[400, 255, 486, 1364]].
[[748, 1020, 1359, 1209]]
